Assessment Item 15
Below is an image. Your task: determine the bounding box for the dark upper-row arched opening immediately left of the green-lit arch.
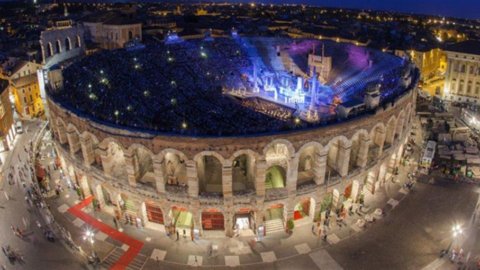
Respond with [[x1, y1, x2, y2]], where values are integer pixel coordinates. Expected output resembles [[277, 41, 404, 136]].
[[232, 154, 255, 194]]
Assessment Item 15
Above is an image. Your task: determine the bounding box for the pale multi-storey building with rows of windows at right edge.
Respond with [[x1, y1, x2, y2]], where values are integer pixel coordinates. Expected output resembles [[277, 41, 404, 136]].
[[443, 40, 480, 104]]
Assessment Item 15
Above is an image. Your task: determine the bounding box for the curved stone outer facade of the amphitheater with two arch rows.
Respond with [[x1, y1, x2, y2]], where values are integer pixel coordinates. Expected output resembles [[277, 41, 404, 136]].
[[48, 88, 416, 236]]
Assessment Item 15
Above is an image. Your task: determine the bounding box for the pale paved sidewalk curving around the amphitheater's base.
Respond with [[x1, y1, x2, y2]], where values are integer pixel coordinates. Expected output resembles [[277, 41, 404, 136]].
[[38, 133, 420, 269]]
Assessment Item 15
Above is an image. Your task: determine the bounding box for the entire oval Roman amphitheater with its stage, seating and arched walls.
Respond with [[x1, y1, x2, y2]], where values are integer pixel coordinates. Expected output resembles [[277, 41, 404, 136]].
[[48, 38, 418, 236]]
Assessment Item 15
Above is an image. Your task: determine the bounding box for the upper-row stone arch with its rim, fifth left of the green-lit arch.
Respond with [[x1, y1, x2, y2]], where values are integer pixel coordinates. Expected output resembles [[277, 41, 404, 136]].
[[100, 137, 127, 179]]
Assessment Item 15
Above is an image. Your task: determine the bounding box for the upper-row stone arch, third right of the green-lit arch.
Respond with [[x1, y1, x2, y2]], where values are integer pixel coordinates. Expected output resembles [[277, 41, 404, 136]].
[[349, 129, 371, 170]]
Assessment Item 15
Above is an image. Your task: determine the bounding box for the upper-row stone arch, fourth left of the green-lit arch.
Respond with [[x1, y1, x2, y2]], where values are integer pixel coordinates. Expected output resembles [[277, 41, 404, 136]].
[[126, 143, 155, 186]]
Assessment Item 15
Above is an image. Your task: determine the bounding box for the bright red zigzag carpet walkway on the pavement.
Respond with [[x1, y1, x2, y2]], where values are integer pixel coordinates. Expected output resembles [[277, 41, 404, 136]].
[[68, 196, 143, 270]]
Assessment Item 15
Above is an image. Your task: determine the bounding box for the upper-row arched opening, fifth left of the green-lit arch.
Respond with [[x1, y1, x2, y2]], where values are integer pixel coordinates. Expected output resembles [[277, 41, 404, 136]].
[[102, 141, 127, 179]]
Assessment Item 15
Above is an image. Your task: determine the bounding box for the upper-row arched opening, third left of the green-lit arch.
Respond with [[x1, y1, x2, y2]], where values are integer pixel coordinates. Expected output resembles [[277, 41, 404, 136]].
[[162, 152, 188, 192]]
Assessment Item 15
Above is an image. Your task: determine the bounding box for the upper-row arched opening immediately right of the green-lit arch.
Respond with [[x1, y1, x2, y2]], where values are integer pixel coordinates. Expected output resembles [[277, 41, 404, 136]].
[[297, 145, 320, 188]]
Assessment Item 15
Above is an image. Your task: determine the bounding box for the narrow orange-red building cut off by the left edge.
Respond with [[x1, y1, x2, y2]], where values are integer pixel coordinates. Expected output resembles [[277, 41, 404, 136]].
[[0, 79, 16, 153]]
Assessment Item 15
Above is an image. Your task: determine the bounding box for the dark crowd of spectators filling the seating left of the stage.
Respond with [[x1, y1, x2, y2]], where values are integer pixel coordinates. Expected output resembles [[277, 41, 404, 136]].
[[49, 38, 414, 136]]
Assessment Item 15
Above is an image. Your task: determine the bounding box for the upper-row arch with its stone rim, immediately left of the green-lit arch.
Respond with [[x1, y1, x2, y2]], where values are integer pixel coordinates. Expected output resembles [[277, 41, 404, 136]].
[[227, 149, 259, 193]]
